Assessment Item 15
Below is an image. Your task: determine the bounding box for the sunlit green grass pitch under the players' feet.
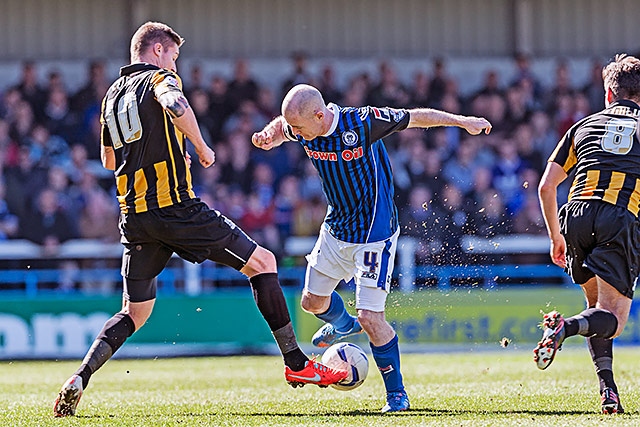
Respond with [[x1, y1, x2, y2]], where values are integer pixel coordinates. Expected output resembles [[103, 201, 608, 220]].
[[0, 348, 640, 427]]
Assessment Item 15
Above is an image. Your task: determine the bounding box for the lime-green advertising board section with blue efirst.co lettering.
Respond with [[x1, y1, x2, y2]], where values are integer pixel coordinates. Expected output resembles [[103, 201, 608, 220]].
[[297, 287, 584, 344]]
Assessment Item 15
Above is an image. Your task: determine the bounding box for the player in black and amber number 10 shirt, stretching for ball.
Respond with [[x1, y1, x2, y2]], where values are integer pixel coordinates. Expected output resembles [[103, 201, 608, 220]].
[[54, 22, 347, 416]]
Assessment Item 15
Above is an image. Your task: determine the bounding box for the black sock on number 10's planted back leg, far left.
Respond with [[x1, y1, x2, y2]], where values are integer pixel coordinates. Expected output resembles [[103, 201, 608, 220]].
[[76, 313, 136, 389]]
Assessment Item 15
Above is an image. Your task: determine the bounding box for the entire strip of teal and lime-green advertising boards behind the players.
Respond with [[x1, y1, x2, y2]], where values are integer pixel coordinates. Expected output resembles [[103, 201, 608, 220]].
[[0, 287, 640, 359]]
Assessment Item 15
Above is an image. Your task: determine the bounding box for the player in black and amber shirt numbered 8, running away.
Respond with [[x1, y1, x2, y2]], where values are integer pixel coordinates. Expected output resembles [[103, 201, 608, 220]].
[[534, 55, 640, 414]]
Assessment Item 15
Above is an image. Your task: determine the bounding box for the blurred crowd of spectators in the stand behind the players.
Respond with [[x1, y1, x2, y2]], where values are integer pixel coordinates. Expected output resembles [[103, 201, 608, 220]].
[[0, 54, 604, 264]]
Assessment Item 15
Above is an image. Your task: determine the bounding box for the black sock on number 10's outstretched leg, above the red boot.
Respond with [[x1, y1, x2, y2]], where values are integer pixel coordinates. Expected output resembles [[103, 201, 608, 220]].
[[249, 273, 309, 371]]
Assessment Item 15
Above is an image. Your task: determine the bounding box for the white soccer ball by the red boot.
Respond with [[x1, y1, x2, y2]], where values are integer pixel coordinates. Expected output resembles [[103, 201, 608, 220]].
[[322, 342, 369, 391]]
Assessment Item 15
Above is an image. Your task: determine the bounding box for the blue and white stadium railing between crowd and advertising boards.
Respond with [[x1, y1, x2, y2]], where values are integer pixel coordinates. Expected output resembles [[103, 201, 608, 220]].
[[0, 235, 568, 297]]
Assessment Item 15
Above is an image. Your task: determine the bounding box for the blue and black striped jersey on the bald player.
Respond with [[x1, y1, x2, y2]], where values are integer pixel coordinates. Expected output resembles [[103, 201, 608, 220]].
[[284, 104, 409, 243]]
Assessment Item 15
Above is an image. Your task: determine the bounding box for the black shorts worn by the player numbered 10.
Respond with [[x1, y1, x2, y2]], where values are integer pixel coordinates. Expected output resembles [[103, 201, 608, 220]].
[[120, 199, 257, 301]]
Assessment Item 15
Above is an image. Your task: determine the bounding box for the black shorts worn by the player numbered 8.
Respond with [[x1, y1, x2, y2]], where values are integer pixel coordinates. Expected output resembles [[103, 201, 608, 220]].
[[558, 200, 640, 298]]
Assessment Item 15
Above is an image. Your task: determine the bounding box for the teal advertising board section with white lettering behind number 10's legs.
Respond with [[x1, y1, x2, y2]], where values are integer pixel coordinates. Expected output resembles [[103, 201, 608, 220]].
[[0, 288, 288, 359]]
